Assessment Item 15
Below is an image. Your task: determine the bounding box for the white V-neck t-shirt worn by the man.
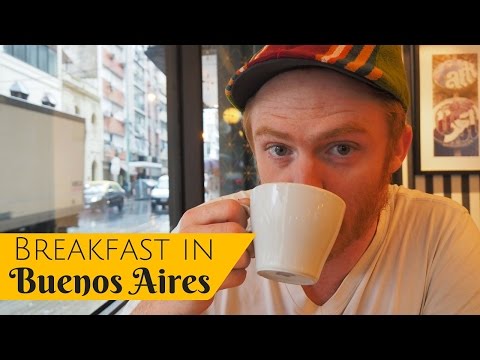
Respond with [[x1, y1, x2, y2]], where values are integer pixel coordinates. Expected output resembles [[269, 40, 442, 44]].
[[119, 185, 480, 315]]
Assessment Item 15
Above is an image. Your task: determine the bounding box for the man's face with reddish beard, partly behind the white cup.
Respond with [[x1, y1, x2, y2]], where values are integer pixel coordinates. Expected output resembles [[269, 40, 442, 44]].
[[250, 69, 398, 250]]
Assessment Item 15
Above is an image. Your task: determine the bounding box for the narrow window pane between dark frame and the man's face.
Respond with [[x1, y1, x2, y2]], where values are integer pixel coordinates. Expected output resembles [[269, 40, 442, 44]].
[[202, 45, 260, 200]]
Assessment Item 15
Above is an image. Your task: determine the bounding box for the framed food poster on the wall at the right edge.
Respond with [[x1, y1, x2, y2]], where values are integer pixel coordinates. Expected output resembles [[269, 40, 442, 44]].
[[414, 45, 480, 174]]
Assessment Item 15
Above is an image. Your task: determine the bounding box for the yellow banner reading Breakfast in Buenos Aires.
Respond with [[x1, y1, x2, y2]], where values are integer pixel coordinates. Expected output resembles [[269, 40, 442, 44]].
[[0, 233, 254, 300]]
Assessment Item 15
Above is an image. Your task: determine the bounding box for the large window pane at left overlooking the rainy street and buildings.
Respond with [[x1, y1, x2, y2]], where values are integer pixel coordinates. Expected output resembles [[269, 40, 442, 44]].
[[0, 45, 170, 314]]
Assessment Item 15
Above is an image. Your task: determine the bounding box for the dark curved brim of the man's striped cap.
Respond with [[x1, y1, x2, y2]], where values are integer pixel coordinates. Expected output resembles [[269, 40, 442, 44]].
[[231, 58, 388, 111]]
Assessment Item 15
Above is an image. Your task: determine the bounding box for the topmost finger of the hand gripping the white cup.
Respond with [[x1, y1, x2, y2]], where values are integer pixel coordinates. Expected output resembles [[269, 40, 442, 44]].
[[181, 199, 248, 228]]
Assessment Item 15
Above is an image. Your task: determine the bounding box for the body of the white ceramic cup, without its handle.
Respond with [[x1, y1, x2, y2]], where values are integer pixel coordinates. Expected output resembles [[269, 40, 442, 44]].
[[250, 183, 346, 285]]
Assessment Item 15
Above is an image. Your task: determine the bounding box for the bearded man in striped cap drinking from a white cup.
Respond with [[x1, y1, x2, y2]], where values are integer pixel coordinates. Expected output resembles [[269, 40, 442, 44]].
[[125, 45, 480, 314]]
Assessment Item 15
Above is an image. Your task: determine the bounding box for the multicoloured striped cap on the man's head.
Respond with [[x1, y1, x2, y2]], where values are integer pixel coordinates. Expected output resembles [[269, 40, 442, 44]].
[[225, 45, 410, 111]]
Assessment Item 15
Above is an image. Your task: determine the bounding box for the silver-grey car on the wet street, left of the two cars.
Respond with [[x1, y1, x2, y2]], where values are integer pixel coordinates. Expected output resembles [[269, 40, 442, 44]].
[[83, 180, 126, 211]]
